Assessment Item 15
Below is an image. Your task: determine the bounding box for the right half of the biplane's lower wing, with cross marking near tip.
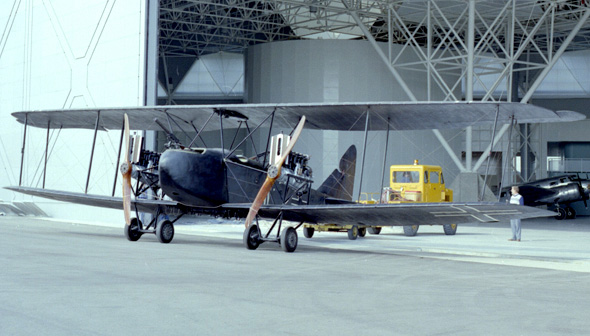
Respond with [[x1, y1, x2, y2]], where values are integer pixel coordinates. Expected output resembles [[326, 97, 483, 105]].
[[225, 202, 555, 226]]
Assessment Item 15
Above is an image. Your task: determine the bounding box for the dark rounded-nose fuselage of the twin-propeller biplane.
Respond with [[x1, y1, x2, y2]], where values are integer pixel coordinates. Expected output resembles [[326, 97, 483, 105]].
[[159, 148, 326, 207]]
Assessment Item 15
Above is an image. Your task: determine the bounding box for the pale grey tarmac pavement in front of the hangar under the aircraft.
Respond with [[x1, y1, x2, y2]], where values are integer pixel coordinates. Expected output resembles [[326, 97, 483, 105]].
[[0, 217, 590, 335]]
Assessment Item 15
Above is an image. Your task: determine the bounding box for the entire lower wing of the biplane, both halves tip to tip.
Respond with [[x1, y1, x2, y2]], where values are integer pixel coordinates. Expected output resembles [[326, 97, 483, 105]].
[[6, 187, 555, 226]]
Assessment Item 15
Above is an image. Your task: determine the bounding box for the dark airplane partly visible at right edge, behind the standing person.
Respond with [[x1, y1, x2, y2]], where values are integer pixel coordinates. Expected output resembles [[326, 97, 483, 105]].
[[500, 174, 590, 220]]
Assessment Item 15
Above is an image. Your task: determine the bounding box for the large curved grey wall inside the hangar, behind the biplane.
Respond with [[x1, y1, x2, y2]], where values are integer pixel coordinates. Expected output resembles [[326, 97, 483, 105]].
[[246, 40, 464, 199]]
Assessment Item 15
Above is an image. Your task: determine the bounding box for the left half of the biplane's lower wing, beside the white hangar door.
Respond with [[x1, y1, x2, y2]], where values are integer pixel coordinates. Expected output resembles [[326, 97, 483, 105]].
[[5, 187, 180, 212]]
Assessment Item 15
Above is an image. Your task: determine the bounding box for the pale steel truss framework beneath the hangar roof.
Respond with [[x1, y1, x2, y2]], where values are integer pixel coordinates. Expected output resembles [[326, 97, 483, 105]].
[[160, 0, 590, 185]]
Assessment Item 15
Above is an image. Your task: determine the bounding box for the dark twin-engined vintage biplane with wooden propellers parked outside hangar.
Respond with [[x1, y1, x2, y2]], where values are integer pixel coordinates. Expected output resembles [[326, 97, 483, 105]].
[[6, 102, 584, 252]]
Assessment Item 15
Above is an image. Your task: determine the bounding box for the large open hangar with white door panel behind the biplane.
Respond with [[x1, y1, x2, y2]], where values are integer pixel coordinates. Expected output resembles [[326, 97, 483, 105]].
[[0, 0, 590, 220]]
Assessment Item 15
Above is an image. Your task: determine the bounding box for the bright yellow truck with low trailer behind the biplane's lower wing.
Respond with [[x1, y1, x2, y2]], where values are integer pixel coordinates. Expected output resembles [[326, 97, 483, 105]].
[[303, 160, 457, 240]]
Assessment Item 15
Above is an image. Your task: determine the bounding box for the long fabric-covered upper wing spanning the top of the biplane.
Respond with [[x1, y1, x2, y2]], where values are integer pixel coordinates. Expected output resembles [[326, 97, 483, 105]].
[[12, 102, 585, 132]]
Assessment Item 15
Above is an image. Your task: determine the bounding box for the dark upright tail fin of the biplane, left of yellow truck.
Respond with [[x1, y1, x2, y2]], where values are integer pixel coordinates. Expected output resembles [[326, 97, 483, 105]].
[[318, 145, 356, 201]]
